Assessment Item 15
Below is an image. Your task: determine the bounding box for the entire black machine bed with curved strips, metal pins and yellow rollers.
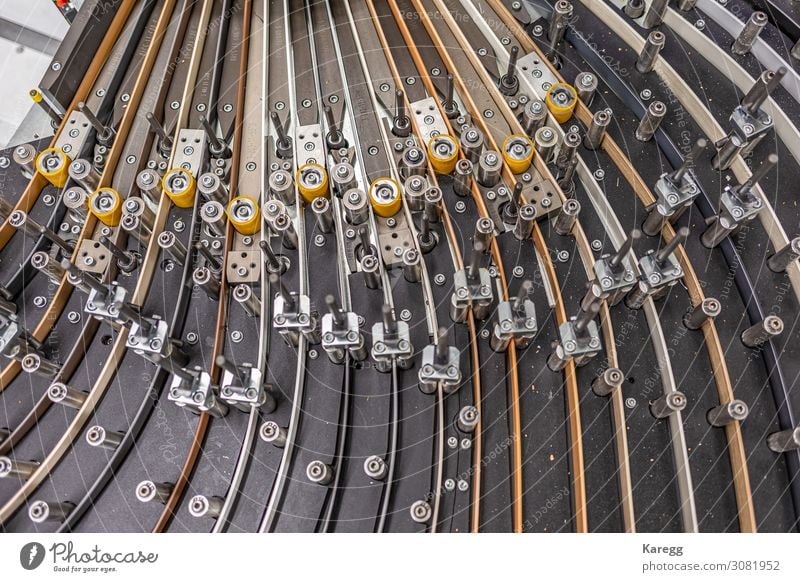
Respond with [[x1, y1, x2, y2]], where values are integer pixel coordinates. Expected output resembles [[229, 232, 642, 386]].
[[0, 0, 800, 533]]
